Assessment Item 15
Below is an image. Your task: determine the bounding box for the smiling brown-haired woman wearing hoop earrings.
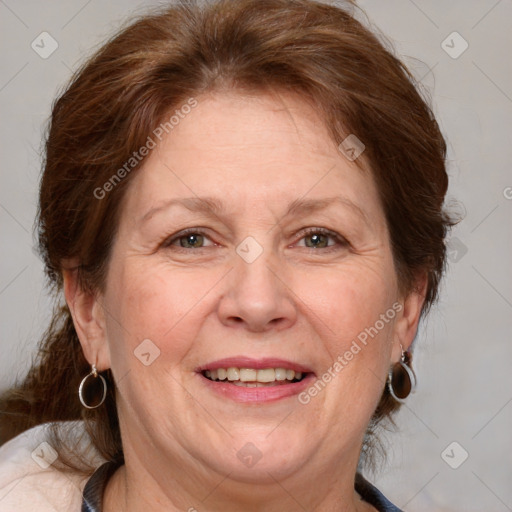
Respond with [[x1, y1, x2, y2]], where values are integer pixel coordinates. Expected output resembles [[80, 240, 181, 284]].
[[0, 0, 451, 512]]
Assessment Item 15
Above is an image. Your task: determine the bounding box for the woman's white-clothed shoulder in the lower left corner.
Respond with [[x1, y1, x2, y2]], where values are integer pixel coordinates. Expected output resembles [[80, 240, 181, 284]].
[[0, 421, 103, 512]]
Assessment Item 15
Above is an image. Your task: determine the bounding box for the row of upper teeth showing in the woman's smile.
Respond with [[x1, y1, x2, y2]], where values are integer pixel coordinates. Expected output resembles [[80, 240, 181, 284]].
[[204, 367, 302, 387]]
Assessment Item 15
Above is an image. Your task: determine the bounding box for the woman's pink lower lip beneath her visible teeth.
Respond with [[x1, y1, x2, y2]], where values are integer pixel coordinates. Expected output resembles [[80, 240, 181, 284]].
[[198, 373, 315, 403]]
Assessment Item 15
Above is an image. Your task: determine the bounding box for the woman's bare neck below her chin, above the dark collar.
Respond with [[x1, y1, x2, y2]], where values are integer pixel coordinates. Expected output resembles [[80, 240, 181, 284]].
[[103, 450, 375, 512]]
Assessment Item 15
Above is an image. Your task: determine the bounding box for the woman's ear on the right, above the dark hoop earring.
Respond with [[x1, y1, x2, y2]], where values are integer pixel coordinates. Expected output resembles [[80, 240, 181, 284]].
[[392, 272, 428, 362]]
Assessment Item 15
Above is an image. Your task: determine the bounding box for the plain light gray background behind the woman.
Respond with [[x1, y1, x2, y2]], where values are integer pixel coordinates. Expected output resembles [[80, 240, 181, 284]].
[[0, 0, 512, 512]]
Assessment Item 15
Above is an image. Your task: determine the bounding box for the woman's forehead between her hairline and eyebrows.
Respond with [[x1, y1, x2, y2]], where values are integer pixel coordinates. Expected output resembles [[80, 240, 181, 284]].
[[121, 92, 378, 222]]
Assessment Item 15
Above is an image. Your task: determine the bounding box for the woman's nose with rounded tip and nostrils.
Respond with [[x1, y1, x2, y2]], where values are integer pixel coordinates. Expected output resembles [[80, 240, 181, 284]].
[[218, 255, 297, 332]]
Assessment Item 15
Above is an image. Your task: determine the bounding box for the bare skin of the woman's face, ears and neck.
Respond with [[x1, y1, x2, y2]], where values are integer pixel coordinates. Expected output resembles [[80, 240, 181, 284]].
[[65, 92, 425, 512]]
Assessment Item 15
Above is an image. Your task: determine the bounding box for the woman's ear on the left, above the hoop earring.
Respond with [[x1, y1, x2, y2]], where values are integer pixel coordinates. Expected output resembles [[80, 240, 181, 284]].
[[63, 267, 110, 371]]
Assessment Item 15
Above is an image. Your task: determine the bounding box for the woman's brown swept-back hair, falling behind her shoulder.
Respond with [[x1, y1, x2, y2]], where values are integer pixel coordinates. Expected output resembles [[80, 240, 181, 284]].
[[0, 0, 452, 469]]
